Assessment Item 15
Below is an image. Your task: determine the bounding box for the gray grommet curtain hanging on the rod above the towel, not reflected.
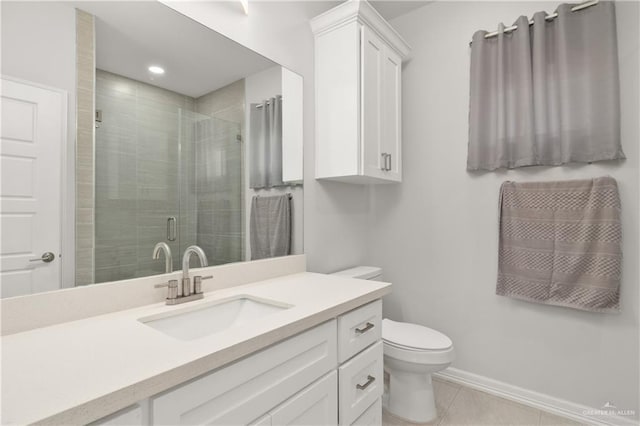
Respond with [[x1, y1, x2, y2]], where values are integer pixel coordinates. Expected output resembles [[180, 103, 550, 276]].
[[467, 1, 625, 170]]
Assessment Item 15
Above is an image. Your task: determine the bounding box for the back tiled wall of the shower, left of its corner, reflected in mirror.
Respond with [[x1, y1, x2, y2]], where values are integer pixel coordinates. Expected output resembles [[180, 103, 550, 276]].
[[95, 70, 194, 282]]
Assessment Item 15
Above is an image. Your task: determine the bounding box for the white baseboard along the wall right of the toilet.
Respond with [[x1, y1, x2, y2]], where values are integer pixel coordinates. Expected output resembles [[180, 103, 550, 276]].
[[434, 367, 639, 426]]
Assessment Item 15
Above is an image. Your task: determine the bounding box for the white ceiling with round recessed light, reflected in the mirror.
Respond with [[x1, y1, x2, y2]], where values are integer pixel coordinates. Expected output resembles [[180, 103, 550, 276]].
[[74, 1, 277, 98]]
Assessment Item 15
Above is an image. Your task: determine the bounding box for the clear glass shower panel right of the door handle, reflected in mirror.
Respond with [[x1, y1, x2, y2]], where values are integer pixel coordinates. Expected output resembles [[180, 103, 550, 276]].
[[180, 110, 244, 266]]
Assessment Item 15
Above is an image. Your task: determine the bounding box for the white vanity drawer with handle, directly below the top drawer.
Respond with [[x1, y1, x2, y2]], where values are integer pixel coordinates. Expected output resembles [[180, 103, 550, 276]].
[[338, 342, 384, 425]]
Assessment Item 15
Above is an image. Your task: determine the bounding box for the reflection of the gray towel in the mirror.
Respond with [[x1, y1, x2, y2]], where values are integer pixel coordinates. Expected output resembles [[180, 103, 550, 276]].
[[250, 195, 291, 260]]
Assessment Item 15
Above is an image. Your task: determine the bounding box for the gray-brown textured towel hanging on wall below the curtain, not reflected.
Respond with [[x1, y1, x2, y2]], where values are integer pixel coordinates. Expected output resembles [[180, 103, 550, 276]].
[[496, 177, 622, 312]]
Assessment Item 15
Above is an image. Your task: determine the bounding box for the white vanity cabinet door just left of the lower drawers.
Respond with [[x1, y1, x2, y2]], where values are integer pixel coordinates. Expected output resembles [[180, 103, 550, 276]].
[[271, 371, 338, 426]]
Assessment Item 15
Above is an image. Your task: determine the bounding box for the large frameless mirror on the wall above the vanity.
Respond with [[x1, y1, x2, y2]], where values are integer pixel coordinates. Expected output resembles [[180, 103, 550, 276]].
[[0, 1, 303, 297]]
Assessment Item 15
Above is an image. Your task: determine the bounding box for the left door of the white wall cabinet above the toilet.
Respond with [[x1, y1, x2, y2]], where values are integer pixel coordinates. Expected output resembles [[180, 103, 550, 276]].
[[360, 25, 385, 178]]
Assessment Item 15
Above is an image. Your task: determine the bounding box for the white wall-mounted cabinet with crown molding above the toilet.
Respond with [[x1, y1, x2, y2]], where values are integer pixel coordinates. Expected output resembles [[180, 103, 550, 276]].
[[311, 0, 410, 183]]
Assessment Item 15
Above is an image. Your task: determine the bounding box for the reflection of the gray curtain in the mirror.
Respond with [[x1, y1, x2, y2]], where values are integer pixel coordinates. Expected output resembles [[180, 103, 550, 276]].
[[249, 96, 283, 188]]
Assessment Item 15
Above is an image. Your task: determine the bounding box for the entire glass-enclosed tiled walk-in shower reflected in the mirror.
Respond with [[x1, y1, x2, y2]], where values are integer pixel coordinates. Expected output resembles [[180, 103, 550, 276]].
[[94, 70, 244, 282]]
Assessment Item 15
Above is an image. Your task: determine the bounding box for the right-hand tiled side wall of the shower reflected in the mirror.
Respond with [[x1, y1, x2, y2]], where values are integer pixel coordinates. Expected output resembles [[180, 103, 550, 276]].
[[195, 79, 246, 265]]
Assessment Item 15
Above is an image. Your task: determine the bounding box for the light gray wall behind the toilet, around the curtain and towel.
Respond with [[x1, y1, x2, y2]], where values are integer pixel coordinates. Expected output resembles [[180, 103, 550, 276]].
[[367, 2, 640, 413]]
